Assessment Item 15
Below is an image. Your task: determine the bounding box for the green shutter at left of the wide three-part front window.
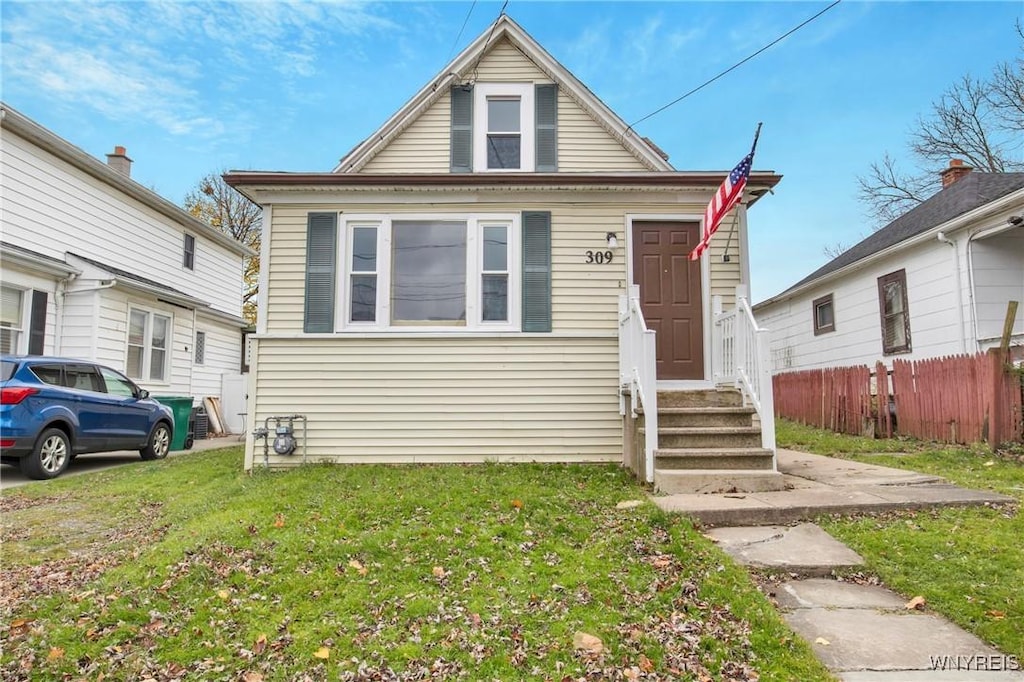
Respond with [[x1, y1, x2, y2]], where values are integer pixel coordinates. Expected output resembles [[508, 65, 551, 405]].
[[302, 213, 338, 332]]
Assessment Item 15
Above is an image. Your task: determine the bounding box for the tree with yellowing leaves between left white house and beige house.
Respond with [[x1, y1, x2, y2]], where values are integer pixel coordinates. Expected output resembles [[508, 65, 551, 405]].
[[184, 173, 261, 325]]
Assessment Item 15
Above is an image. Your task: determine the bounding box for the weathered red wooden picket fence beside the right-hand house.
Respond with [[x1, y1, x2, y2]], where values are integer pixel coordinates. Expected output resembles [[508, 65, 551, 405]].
[[773, 350, 1024, 446]]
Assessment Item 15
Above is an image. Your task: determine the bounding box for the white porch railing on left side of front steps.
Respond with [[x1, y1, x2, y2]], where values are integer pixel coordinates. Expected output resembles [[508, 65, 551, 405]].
[[618, 285, 657, 482]]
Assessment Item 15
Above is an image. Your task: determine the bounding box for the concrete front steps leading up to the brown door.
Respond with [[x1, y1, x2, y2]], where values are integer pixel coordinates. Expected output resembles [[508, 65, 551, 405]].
[[637, 389, 783, 494]]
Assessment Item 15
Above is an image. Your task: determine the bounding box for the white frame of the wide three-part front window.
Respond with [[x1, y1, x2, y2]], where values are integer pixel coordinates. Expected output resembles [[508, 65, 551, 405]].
[[335, 213, 522, 335]]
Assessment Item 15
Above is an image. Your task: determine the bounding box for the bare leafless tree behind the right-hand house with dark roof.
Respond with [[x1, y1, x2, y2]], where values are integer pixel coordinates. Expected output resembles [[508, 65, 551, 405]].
[[857, 23, 1024, 229]]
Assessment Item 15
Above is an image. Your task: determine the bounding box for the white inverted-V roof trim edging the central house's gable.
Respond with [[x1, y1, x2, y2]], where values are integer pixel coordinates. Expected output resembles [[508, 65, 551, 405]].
[[333, 14, 674, 173]]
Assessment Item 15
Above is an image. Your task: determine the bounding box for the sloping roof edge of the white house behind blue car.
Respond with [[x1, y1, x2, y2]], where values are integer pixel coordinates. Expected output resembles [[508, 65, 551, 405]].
[[0, 102, 257, 256]]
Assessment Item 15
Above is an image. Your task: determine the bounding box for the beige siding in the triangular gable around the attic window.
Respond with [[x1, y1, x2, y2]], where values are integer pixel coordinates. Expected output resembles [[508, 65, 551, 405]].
[[360, 40, 648, 173]]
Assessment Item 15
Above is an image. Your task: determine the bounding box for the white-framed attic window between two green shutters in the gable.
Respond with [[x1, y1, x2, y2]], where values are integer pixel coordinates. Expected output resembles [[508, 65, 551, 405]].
[[473, 83, 535, 171]]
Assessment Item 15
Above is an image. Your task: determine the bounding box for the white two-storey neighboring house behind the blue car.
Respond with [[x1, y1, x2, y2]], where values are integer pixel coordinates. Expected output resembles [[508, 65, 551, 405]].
[[0, 103, 253, 430]]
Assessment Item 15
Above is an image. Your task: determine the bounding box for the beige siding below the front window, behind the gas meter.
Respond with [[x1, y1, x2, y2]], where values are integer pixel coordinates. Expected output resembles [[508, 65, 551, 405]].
[[248, 337, 622, 467]]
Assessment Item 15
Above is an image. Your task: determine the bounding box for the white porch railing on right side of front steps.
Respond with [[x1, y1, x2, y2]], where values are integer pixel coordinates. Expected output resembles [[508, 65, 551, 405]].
[[712, 286, 775, 455]]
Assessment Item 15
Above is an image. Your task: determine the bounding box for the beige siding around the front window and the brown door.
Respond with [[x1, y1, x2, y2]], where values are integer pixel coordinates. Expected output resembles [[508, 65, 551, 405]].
[[266, 201, 740, 334]]
